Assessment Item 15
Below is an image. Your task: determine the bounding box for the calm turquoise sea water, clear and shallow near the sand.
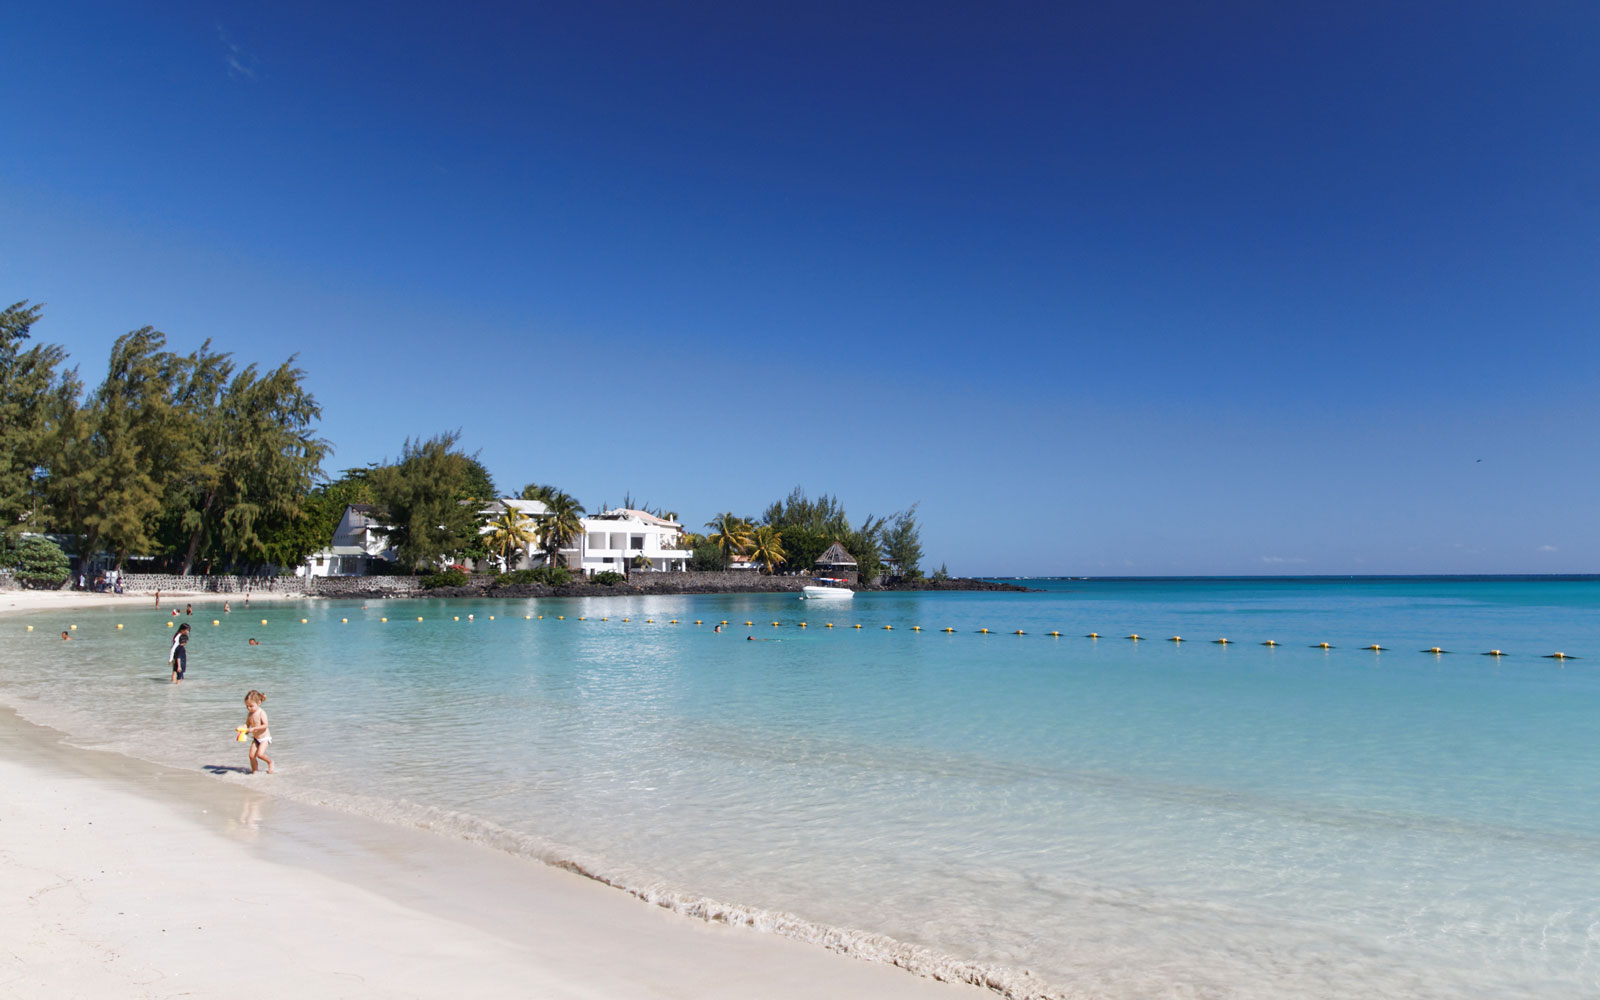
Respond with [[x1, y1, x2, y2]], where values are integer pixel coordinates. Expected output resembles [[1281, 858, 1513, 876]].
[[0, 578, 1600, 998]]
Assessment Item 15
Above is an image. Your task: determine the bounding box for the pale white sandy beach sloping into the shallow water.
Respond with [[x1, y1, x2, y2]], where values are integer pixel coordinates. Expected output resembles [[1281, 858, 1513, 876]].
[[0, 592, 987, 1000]]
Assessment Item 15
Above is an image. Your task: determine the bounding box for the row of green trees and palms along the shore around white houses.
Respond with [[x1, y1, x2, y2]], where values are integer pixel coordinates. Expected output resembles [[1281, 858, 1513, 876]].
[[0, 301, 989, 595]]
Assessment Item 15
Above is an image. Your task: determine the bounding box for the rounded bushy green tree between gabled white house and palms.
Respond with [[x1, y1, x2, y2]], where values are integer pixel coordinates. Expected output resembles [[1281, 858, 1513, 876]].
[[366, 432, 482, 568]]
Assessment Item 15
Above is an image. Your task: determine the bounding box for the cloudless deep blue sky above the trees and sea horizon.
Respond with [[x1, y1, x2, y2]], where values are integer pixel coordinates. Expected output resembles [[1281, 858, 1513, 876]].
[[0, 0, 1600, 574]]
